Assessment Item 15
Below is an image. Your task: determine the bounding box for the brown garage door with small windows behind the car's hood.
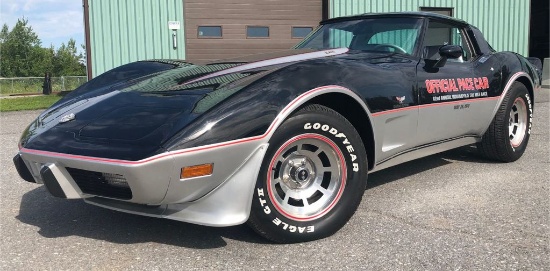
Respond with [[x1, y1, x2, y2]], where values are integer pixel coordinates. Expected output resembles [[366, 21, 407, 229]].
[[184, 0, 322, 61]]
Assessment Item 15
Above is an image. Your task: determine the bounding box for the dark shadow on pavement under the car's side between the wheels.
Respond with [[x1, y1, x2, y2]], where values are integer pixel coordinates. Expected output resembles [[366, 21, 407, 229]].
[[367, 145, 499, 189]]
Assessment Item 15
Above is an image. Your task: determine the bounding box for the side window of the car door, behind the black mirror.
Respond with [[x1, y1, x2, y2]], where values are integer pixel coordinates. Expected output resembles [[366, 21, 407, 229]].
[[423, 21, 472, 62]]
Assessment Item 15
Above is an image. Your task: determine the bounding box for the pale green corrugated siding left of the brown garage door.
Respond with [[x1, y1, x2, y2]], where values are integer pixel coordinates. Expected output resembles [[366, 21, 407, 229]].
[[88, 0, 185, 77]]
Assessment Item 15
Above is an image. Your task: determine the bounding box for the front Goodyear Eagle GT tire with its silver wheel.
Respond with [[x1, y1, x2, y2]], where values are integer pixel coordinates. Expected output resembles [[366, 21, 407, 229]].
[[248, 105, 367, 243]]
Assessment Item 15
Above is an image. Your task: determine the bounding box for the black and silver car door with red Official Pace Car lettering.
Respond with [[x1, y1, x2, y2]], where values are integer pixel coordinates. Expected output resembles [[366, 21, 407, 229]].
[[417, 20, 488, 146]]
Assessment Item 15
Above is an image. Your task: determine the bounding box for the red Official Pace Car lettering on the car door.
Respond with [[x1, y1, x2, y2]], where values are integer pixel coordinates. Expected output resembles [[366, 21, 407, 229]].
[[426, 77, 489, 102]]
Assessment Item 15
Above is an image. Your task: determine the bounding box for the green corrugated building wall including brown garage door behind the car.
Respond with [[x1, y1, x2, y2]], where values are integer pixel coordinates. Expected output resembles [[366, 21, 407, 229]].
[[87, 0, 536, 77]]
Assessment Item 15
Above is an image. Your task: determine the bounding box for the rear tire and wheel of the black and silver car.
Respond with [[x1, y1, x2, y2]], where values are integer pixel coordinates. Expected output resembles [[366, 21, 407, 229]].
[[477, 82, 533, 162]]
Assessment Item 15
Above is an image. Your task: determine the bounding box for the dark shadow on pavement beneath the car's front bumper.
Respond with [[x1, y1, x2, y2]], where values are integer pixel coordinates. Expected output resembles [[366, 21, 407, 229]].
[[16, 186, 268, 249]]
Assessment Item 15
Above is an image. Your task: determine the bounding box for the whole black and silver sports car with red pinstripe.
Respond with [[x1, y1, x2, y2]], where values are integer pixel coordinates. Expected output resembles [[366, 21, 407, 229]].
[[14, 13, 540, 242]]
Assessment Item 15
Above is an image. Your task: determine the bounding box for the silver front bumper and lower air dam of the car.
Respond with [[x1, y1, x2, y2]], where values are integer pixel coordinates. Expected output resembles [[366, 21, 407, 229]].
[[14, 140, 267, 226]]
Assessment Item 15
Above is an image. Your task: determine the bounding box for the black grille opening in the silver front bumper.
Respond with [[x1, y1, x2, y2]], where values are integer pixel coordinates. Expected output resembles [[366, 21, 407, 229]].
[[66, 168, 132, 200]]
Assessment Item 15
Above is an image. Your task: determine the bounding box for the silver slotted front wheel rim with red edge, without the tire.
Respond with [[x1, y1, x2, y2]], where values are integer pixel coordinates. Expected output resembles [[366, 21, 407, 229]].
[[267, 134, 346, 221]]
